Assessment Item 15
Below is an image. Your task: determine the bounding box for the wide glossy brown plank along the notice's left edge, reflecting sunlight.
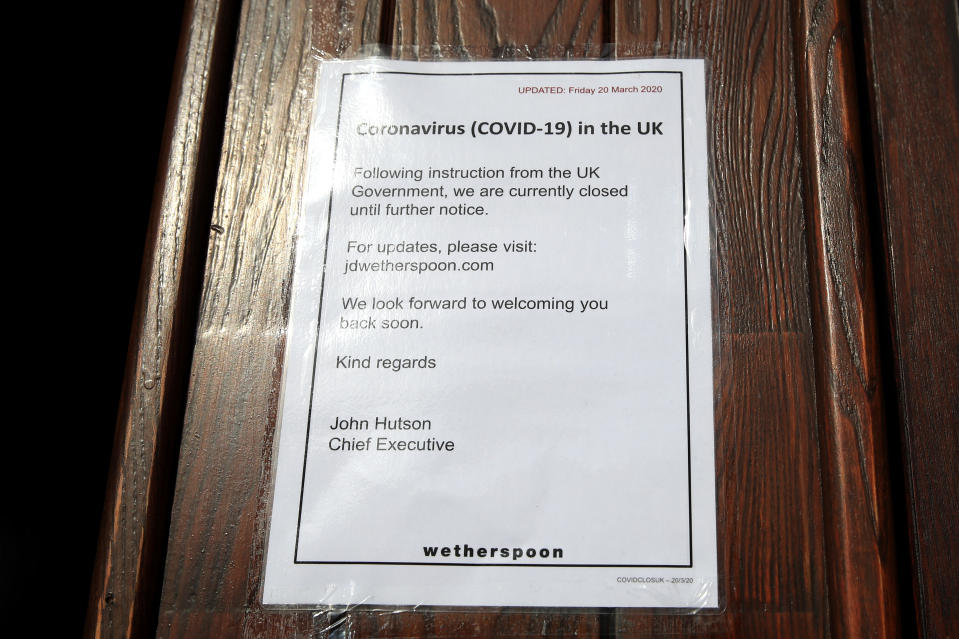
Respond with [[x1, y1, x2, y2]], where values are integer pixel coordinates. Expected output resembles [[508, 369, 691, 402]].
[[157, 0, 378, 638]]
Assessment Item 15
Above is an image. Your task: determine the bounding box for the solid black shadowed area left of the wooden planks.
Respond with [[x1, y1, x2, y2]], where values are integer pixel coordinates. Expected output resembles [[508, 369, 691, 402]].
[[0, 0, 183, 637]]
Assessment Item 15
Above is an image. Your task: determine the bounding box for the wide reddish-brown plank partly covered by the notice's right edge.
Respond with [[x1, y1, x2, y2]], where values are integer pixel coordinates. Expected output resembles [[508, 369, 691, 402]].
[[615, 0, 829, 637]]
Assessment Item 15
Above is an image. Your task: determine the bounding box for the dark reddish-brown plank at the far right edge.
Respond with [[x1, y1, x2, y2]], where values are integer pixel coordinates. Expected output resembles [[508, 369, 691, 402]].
[[862, 0, 959, 638]]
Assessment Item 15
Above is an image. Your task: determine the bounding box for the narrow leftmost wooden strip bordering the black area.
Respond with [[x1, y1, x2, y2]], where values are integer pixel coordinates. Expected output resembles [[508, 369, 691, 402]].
[[85, 0, 242, 638]]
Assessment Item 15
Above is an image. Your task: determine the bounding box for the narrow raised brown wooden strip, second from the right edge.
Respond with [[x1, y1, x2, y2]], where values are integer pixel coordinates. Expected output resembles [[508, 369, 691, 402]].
[[793, 0, 902, 637]]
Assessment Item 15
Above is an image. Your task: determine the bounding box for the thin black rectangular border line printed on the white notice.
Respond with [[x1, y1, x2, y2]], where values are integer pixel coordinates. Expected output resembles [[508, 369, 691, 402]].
[[293, 71, 693, 568]]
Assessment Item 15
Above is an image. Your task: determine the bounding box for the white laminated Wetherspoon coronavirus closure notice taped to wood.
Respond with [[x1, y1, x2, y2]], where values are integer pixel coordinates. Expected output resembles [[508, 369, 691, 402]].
[[263, 60, 718, 608]]
